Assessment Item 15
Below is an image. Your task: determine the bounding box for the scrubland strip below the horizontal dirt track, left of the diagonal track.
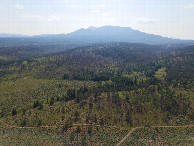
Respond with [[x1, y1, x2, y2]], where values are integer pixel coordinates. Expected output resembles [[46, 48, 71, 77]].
[[0, 126, 127, 145]]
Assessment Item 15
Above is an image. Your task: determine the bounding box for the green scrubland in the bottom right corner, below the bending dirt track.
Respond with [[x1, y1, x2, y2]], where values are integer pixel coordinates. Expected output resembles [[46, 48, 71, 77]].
[[122, 127, 194, 145]]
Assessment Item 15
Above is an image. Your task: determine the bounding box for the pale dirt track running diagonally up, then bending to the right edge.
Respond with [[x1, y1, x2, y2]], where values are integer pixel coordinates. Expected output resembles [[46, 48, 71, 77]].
[[117, 125, 194, 146]]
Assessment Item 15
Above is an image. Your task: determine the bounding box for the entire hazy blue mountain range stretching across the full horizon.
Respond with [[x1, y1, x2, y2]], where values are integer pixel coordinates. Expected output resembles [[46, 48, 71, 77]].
[[0, 26, 194, 45]]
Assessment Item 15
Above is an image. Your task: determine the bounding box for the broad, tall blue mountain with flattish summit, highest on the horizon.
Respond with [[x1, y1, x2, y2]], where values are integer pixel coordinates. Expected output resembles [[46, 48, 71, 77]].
[[66, 26, 194, 44]]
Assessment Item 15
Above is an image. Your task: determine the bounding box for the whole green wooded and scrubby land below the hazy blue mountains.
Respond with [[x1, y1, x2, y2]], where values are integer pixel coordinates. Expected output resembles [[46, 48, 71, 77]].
[[0, 43, 194, 145]]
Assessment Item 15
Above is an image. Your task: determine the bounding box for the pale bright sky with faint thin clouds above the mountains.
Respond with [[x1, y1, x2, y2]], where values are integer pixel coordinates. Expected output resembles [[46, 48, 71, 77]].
[[0, 0, 194, 40]]
